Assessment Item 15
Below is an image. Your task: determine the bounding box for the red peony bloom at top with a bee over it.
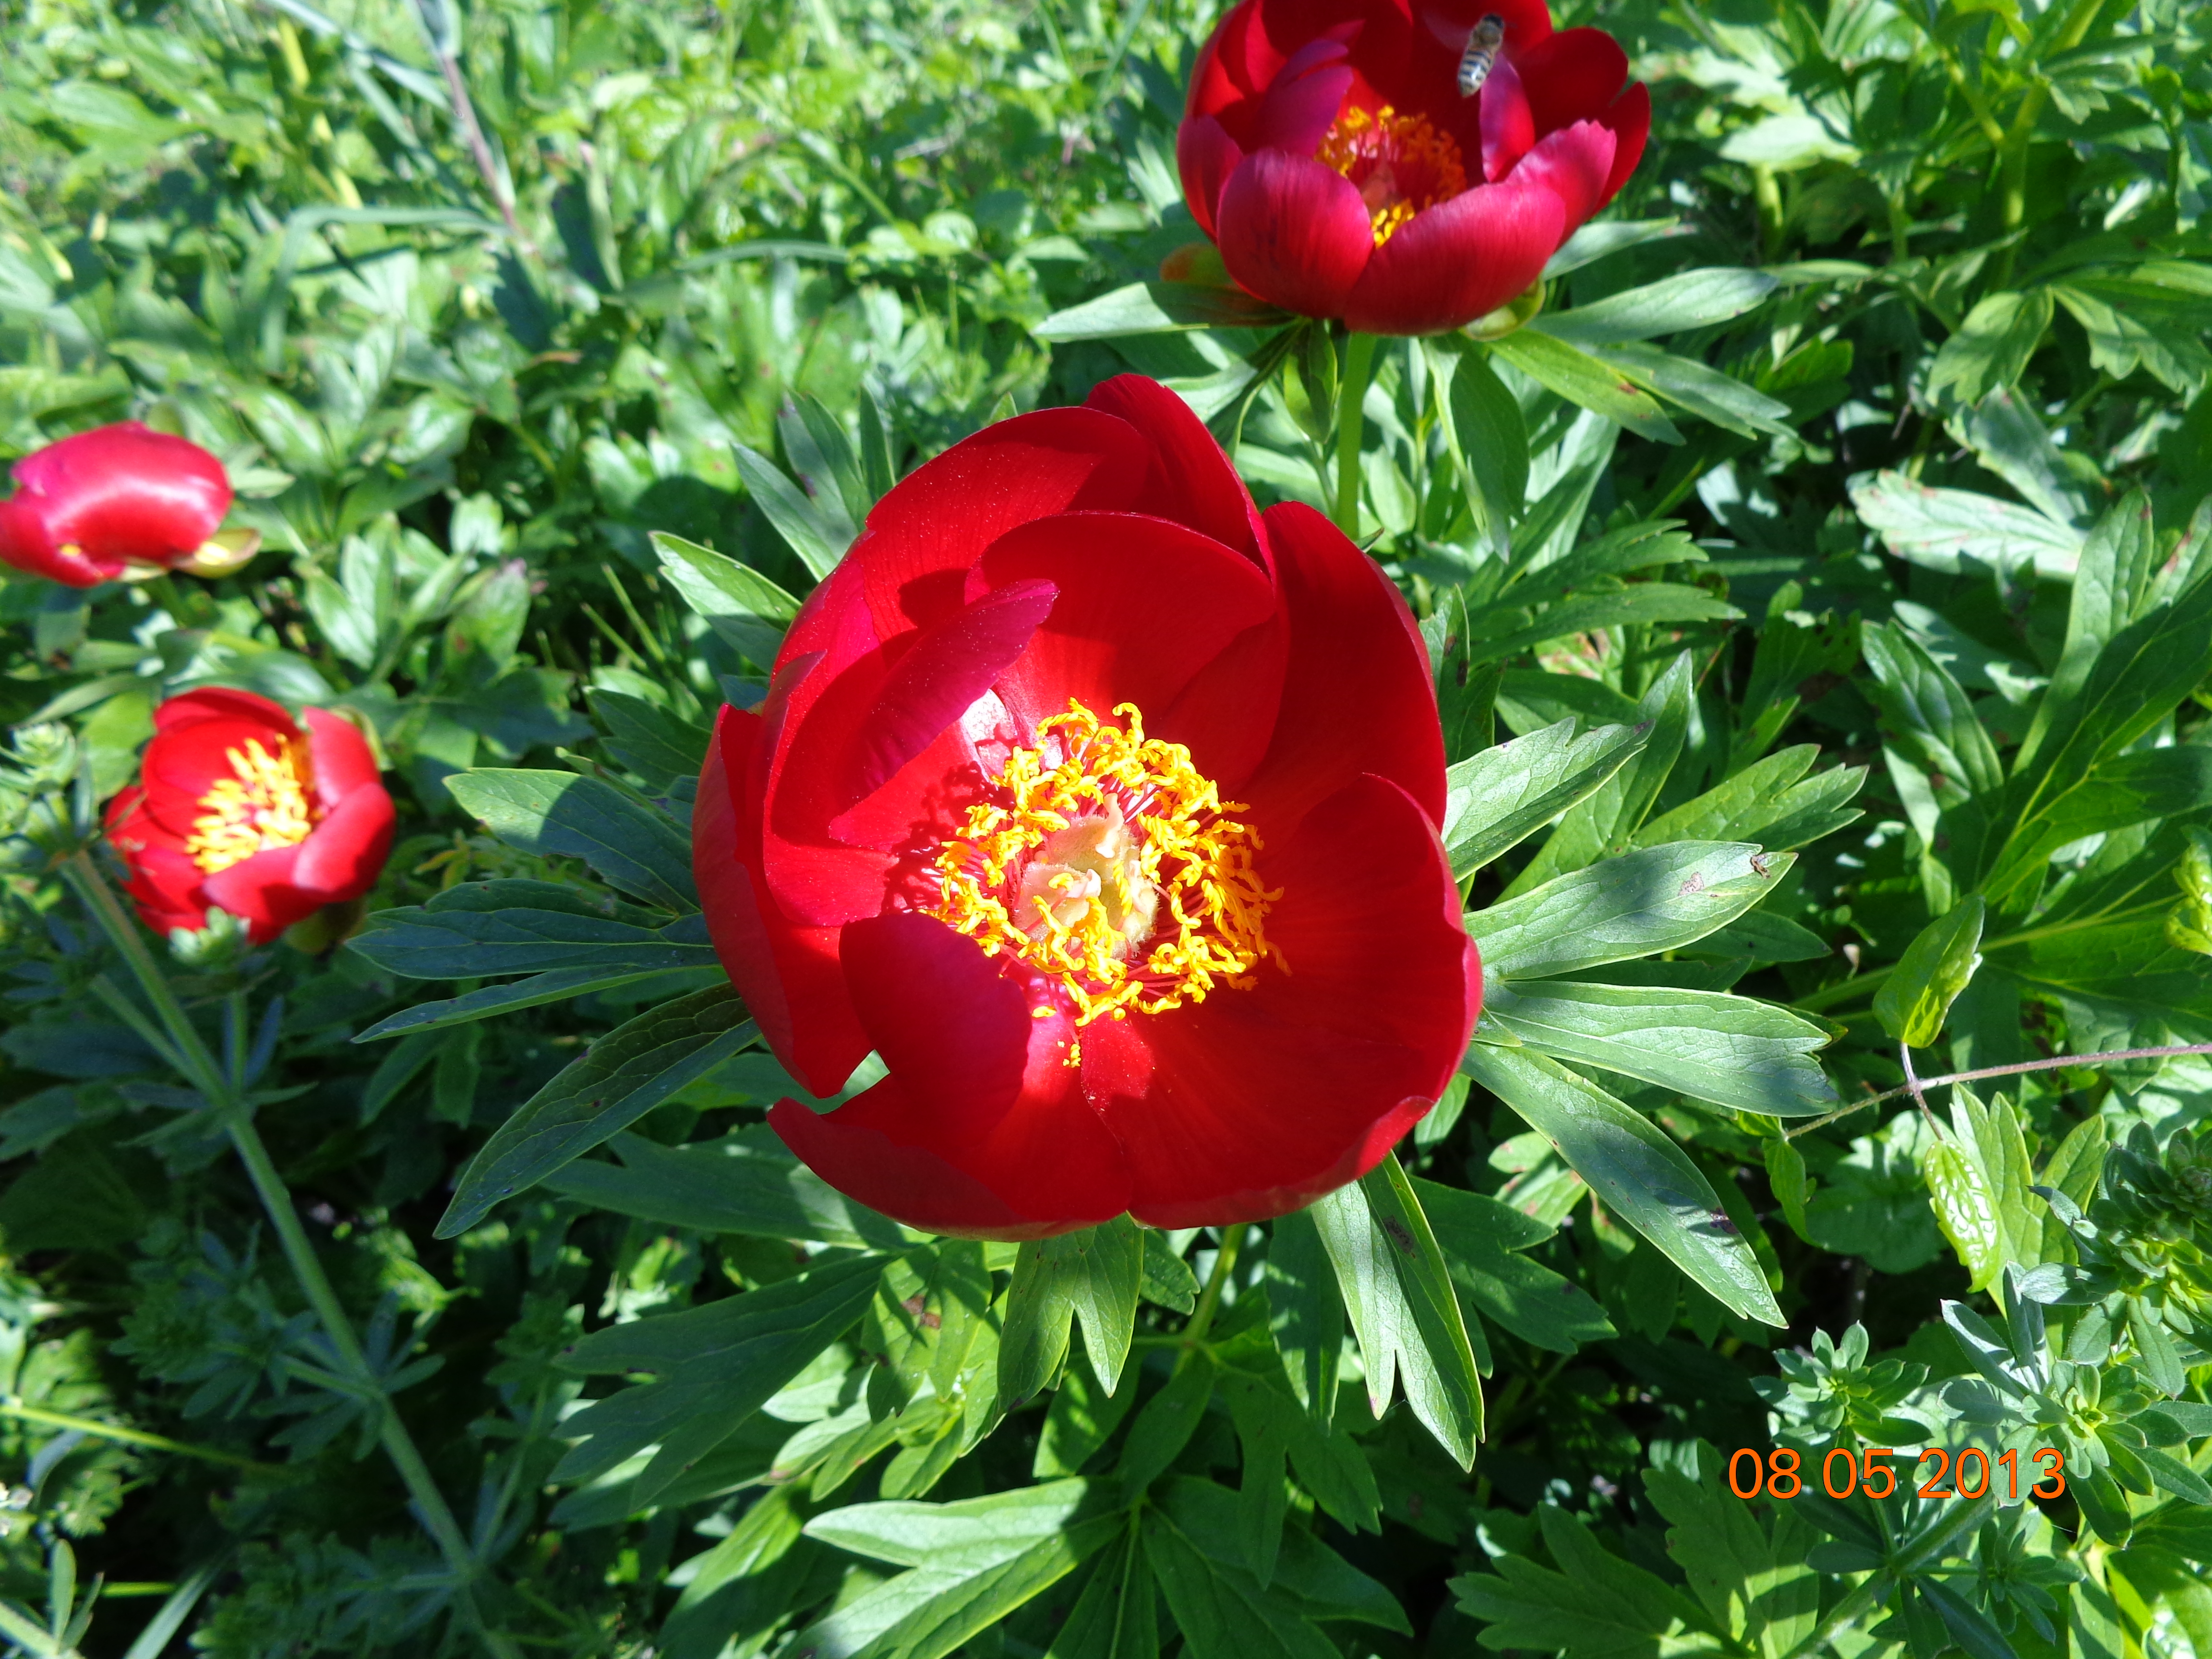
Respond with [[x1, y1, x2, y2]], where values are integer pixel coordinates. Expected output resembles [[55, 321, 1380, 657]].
[[1175, 0, 1652, 334]]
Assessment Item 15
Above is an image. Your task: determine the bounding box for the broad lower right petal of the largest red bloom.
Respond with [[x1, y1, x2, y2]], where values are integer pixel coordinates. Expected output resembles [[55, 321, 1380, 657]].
[[1084, 776, 1480, 1227]]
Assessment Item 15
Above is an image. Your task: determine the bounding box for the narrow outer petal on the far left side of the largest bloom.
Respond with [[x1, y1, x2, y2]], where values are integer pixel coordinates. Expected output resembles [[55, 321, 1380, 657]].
[[692, 708, 869, 1110]]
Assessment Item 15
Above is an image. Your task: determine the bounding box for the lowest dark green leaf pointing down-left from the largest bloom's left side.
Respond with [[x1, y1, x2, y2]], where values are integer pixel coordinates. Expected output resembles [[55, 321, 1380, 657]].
[[438, 985, 759, 1238]]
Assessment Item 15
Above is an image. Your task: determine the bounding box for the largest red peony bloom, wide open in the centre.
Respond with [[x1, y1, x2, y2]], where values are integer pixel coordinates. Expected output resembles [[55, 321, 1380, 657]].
[[692, 376, 1480, 1238]]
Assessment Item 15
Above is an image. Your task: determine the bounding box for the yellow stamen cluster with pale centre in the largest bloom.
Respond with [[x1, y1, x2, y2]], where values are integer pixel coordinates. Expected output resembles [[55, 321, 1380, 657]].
[[925, 699, 1289, 1026]]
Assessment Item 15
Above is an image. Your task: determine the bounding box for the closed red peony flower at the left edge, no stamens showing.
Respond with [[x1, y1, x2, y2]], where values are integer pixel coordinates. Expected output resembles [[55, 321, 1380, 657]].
[[0, 421, 252, 589]]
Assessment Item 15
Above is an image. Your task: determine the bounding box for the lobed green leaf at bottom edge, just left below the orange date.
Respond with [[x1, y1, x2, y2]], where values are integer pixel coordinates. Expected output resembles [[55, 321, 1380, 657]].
[[1449, 1504, 1725, 1659]]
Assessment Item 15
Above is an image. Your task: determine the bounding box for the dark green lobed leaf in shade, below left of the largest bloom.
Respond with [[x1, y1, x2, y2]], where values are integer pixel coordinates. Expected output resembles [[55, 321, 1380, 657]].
[[549, 1256, 883, 1509]]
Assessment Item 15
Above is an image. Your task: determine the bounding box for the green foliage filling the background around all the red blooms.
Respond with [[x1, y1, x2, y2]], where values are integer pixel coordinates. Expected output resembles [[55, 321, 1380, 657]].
[[0, 0, 2212, 1659]]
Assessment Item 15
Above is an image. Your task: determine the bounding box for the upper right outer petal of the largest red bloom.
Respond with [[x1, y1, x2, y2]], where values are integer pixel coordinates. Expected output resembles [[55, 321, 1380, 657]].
[[1238, 504, 1444, 836]]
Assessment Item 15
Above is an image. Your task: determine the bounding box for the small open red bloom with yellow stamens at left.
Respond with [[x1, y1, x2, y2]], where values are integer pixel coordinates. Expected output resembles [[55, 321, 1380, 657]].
[[108, 690, 394, 945]]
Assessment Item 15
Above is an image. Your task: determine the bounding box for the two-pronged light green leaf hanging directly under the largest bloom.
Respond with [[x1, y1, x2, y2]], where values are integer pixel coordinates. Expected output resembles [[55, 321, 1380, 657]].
[[998, 1214, 1143, 1405]]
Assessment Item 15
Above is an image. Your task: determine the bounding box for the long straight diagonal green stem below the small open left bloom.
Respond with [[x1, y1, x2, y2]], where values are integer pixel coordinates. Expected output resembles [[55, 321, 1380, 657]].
[[62, 849, 522, 1659]]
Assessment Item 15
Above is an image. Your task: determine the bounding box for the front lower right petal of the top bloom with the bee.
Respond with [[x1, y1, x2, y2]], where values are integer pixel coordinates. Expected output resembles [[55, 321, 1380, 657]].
[[1343, 179, 1564, 334]]
